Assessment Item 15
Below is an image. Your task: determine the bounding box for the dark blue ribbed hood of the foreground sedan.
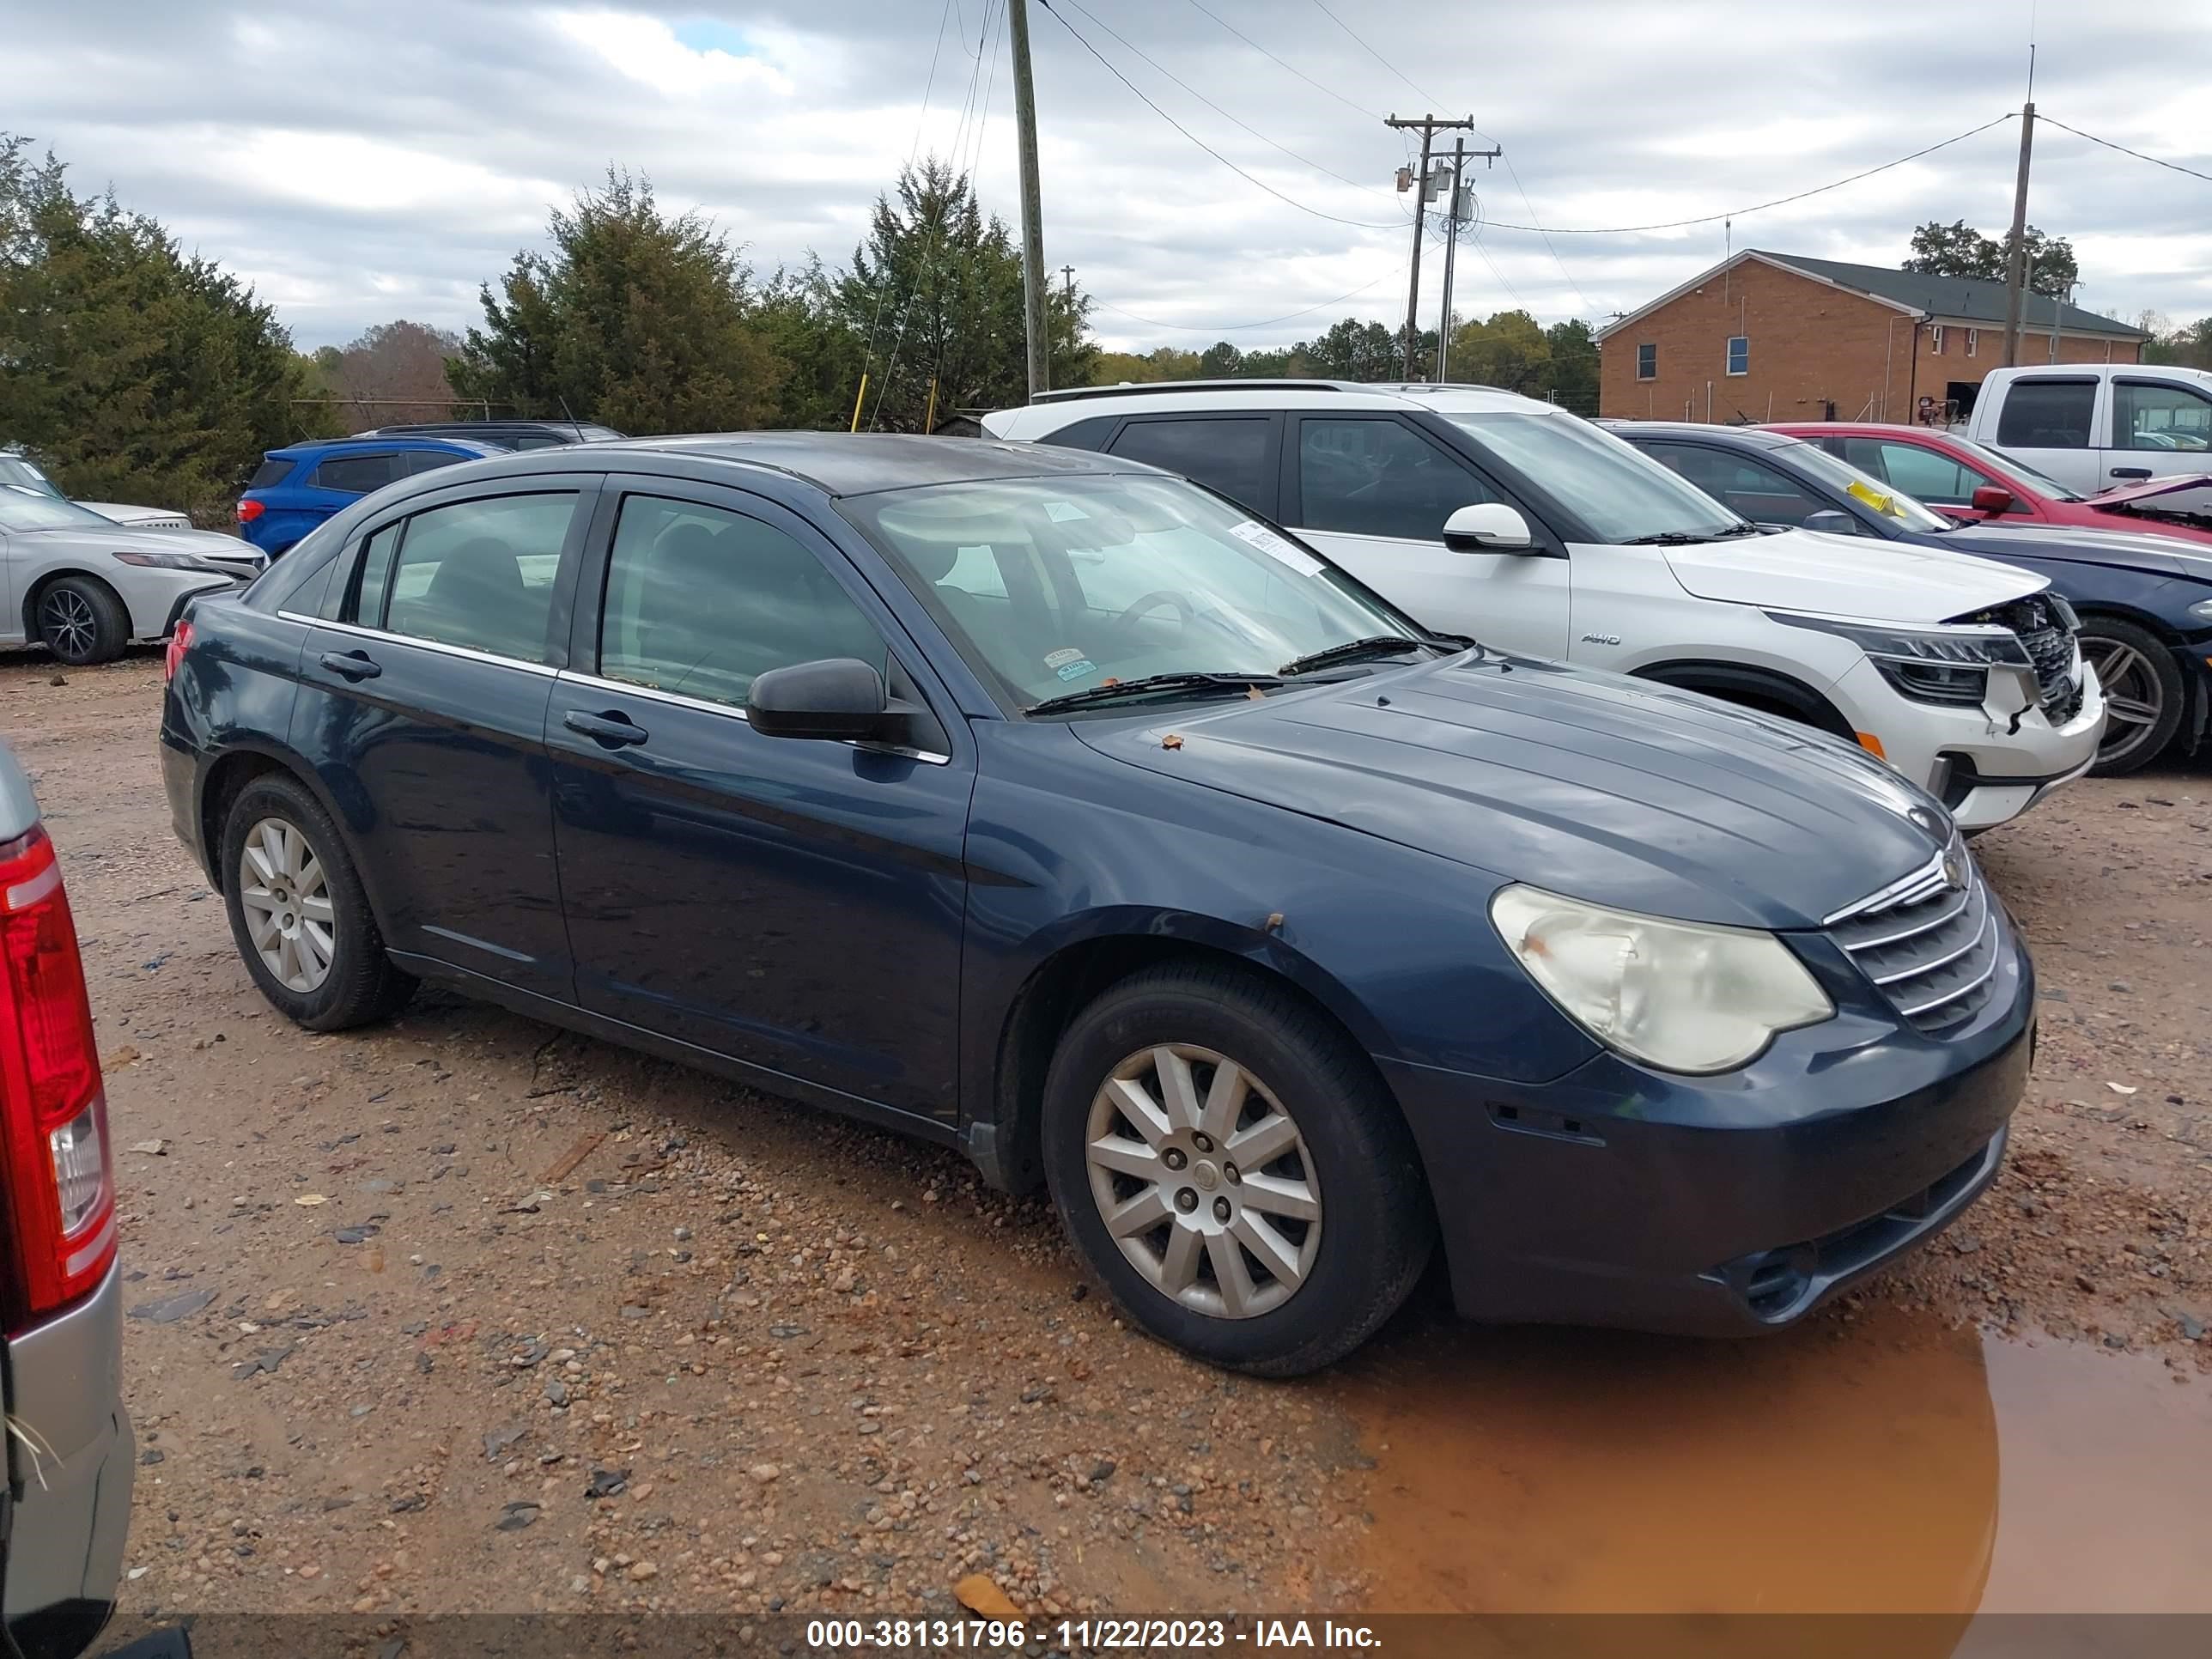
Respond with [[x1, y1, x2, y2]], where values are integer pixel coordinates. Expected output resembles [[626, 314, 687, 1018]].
[[1071, 654, 1948, 929]]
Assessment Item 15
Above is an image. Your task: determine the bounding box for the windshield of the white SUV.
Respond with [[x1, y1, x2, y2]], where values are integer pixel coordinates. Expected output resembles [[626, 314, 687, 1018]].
[[1444, 411, 1743, 546]]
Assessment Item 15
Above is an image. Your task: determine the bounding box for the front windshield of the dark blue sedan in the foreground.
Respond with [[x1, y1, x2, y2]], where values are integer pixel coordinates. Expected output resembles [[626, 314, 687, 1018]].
[[838, 476, 1422, 708]]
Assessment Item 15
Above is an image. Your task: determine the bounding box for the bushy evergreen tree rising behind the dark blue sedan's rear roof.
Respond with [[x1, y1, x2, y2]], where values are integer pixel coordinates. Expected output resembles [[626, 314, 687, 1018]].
[[447, 168, 787, 434]]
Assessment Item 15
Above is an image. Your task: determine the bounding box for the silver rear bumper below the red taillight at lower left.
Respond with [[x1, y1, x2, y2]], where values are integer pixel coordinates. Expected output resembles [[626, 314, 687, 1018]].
[[4, 1267, 135, 1659]]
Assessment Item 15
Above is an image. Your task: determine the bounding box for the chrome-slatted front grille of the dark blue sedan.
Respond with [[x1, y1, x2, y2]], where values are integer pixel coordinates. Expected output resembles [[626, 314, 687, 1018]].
[[1827, 838, 1997, 1033]]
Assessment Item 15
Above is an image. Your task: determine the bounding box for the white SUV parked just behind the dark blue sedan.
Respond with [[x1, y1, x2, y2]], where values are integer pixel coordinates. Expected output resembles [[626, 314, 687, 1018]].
[[982, 380, 2104, 832]]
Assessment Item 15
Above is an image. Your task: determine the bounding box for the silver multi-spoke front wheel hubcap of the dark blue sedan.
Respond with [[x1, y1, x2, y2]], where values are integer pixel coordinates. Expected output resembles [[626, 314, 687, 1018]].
[[1084, 1044, 1321, 1318]]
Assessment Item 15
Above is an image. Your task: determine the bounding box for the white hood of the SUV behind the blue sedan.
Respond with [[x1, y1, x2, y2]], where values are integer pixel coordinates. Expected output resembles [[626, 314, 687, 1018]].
[[1662, 531, 2048, 622]]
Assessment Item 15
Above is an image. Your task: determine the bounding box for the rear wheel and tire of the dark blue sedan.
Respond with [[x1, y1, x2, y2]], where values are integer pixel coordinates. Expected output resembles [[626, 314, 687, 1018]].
[[222, 772, 416, 1030]]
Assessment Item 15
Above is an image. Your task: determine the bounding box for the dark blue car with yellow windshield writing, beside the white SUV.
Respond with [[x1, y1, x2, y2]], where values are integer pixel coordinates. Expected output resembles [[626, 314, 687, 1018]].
[[1604, 420, 2212, 776]]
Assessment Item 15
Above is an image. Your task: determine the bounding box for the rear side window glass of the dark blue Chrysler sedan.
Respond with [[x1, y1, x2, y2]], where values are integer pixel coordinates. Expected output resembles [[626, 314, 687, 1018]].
[[356, 491, 577, 661]]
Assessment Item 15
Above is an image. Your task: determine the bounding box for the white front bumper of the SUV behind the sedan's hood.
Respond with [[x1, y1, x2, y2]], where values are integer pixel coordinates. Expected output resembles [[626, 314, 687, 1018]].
[[1834, 661, 2104, 832]]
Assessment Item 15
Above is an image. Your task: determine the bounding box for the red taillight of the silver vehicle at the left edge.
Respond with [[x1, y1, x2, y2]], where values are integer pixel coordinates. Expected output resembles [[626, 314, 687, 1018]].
[[0, 830, 115, 1332]]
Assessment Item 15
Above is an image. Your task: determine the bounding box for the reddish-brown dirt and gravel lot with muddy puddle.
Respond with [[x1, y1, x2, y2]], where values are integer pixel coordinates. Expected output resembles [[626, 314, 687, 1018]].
[[0, 654, 2212, 1614]]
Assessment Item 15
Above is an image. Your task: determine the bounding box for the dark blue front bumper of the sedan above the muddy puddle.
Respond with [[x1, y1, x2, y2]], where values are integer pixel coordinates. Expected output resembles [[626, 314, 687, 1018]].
[[1382, 927, 2035, 1336]]
